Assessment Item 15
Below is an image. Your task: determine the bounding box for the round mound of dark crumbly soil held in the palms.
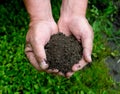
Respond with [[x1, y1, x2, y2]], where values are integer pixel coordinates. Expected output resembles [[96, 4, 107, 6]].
[[45, 33, 82, 74]]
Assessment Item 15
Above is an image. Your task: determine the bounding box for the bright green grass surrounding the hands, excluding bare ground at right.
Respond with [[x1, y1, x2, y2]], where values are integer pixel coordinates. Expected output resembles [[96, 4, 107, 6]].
[[0, 0, 120, 94]]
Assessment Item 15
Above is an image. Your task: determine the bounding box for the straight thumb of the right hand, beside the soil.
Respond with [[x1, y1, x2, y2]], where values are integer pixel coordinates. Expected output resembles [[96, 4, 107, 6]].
[[81, 32, 93, 62]]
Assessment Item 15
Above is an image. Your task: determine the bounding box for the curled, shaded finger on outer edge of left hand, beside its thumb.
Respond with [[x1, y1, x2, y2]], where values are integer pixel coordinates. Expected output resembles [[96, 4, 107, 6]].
[[25, 46, 41, 71]]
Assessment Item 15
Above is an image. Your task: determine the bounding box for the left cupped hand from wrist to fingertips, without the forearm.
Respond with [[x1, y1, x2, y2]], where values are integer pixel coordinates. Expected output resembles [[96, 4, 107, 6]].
[[25, 20, 58, 72]]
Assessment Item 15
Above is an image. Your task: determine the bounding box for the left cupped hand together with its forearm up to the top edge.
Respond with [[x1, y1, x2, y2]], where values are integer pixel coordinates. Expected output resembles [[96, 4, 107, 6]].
[[24, 0, 63, 75]]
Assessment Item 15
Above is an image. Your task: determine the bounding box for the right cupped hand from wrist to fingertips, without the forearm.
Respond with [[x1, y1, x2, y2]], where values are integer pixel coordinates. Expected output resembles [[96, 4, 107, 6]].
[[58, 16, 93, 77]]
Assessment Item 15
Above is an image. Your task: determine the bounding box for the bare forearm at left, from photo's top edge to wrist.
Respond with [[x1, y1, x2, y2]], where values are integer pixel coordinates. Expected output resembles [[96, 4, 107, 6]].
[[24, 0, 53, 21]]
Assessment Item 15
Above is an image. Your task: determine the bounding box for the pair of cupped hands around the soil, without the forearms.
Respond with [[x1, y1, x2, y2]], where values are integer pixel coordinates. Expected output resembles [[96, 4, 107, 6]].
[[25, 16, 93, 78]]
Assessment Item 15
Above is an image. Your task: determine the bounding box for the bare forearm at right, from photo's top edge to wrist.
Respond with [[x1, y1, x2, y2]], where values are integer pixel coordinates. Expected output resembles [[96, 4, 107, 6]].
[[61, 0, 88, 16]]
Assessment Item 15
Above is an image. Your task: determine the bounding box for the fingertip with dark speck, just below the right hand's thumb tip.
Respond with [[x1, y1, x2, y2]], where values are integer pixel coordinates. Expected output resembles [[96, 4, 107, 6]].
[[72, 58, 88, 71]]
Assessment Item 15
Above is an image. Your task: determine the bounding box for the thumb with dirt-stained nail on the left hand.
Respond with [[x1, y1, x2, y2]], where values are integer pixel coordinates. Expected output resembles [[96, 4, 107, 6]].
[[32, 43, 48, 70]]
